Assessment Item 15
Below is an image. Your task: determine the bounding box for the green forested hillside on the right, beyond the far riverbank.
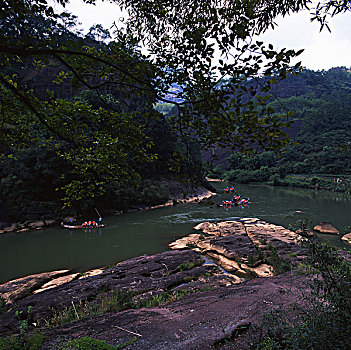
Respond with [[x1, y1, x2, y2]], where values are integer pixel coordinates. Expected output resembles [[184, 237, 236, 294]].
[[211, 68, 351, 191]]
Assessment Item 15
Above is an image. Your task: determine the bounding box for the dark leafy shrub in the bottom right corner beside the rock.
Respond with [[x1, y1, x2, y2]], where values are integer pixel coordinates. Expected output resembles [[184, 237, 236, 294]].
[[254, 241, 351, 350]]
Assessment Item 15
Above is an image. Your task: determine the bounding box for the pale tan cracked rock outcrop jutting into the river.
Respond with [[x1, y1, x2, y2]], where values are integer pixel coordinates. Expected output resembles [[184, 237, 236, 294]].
[[169, 218, 305, 279]]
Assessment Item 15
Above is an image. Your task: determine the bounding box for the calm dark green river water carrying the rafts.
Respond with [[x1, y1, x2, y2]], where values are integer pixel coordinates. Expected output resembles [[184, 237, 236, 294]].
[[0, 183, 351, 283]]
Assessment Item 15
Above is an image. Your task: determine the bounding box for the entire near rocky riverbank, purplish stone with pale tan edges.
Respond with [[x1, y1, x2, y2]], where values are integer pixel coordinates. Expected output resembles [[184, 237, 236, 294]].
[[0, 218, 314, 349]]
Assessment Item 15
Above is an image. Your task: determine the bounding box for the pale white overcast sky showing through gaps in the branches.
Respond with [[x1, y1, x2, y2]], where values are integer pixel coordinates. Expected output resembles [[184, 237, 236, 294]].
[[56, 0, 351, 70]]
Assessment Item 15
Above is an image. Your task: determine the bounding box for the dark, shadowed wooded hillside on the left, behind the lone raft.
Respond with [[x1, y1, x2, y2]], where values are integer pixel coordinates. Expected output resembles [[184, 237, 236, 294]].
[[0, 14, 203, 220]]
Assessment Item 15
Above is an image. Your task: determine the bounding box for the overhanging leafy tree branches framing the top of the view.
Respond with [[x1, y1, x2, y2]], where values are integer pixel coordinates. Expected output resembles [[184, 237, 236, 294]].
[[0, 0, 350, 205]]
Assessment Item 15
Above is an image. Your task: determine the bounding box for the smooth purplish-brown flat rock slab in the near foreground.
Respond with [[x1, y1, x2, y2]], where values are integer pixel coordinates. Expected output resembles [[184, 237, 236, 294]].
[[43, 274, 307, 350]]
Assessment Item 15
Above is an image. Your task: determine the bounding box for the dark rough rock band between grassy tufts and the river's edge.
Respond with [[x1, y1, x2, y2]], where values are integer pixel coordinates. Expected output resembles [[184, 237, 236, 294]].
[[0, 250, 237, 333]]
